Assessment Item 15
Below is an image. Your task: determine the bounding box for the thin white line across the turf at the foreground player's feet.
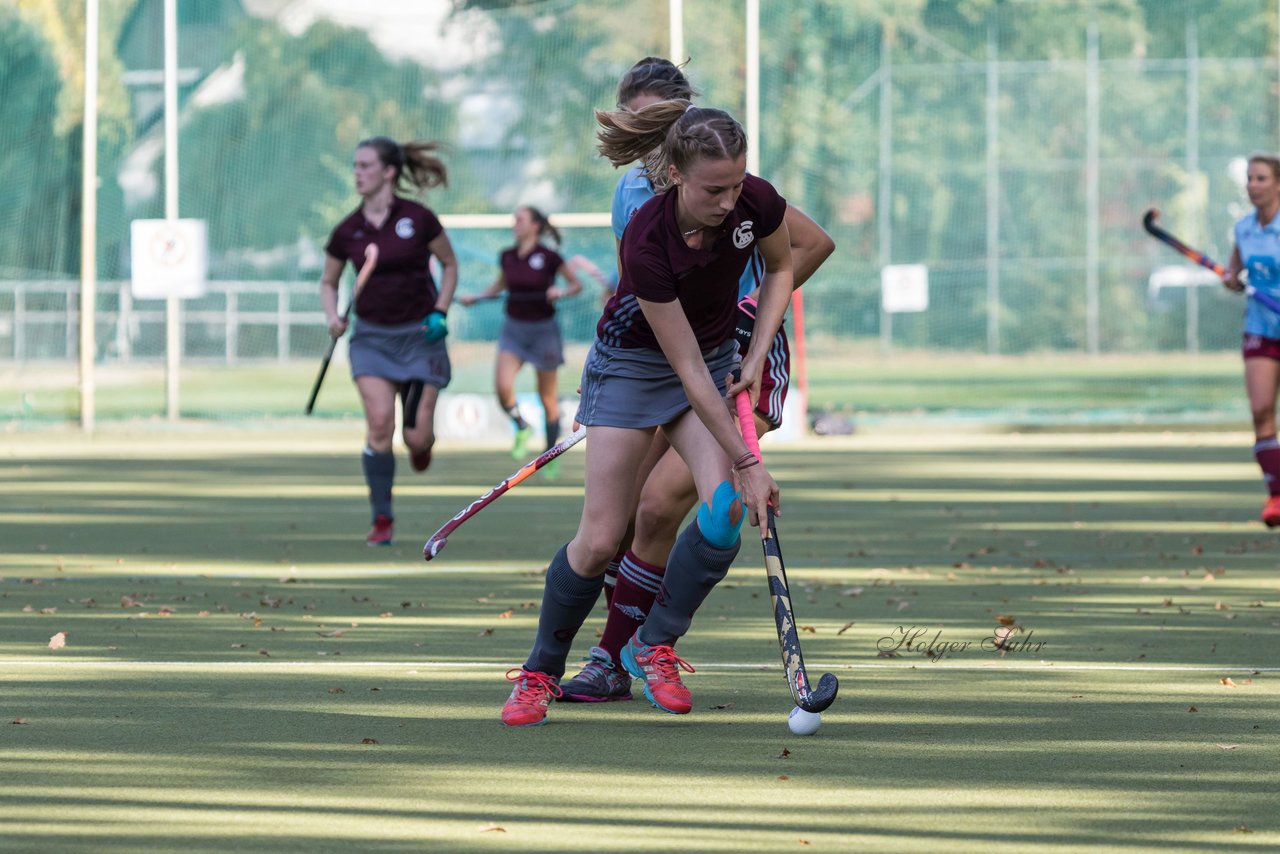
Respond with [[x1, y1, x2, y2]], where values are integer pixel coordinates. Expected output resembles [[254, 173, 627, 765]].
[[0, 658, 1280, 673]]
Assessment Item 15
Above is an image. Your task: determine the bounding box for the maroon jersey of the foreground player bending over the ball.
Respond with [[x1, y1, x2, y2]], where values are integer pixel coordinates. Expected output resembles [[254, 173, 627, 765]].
[[595, 175, 787, 352]]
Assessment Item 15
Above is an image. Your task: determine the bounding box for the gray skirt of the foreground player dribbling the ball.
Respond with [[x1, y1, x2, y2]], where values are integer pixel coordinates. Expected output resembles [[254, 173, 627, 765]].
[[577, 339, 739, 428]]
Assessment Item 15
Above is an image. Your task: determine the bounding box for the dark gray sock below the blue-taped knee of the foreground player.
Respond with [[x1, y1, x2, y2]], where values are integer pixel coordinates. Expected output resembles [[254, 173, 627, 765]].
[[637, 520, 742, 645]]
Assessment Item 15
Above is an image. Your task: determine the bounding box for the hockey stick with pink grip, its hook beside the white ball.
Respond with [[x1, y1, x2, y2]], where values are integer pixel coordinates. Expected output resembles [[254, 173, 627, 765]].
[[733, 392, 840, 712]]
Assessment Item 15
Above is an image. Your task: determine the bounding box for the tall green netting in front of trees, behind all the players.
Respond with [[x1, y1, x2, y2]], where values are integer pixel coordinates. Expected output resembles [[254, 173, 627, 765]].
[[0, 0, 1280, 423]]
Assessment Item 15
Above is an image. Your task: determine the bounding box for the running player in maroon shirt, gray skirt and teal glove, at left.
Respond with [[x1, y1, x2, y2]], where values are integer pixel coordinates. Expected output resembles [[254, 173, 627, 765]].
[[320, 137, 458, 545]]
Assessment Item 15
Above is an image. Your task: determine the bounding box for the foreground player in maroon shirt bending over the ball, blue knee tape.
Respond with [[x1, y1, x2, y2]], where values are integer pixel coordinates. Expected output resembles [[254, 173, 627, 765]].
[[502, 100, 792, 726]]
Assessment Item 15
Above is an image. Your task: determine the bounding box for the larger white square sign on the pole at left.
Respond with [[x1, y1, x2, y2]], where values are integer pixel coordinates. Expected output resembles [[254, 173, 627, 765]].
[[129, 219, 209, 300]]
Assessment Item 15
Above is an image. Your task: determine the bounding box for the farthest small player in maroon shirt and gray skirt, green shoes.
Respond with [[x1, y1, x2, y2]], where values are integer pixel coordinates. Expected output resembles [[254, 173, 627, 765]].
[[458, 205, 582, 478]]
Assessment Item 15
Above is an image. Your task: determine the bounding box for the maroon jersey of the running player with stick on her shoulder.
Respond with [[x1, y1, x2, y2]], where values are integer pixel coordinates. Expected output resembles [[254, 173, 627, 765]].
[[324, 196, 444, 325]]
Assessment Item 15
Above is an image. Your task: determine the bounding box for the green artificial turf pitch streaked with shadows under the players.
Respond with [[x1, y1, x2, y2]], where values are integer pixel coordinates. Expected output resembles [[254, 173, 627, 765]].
[[0, 423, 1280, 854]]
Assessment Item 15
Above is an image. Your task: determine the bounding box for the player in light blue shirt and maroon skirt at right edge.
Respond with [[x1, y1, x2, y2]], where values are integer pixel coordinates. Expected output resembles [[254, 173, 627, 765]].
[[1222, 154, 1280, 528]]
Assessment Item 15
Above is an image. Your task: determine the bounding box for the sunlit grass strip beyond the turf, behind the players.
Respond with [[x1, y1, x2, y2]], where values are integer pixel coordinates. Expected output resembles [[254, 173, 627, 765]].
[[0, 342, 1248, 426]]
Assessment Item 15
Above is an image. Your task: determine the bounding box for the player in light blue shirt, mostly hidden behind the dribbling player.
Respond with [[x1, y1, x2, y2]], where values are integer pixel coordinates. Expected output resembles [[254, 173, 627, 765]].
[[559, 56, 836, 703]]
